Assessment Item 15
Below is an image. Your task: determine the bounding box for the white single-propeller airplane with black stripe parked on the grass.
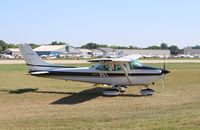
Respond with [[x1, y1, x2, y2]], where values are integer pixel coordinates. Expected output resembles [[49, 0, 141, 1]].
[[19, 44, 169, 96]]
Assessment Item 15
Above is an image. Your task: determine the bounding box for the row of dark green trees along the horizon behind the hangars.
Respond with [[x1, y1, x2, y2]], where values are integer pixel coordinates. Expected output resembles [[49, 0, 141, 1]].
[[0, 40, 200, 55]]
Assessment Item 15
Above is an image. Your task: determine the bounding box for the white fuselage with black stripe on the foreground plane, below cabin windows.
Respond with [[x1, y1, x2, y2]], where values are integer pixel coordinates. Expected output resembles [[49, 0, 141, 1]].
[[31, 67, 163, 86]]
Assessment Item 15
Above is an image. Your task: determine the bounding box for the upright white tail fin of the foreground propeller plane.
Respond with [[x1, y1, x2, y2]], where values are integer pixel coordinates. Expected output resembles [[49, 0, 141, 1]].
[[18, 43, 53, 71]]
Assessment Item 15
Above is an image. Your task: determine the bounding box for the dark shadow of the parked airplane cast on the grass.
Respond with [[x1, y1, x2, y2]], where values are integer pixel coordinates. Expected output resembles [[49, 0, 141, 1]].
[[0, 87, 141, 105]]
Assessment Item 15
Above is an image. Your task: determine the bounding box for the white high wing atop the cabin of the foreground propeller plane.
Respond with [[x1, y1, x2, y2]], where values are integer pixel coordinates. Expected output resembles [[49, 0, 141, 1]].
[[88, 54, 142, 63]]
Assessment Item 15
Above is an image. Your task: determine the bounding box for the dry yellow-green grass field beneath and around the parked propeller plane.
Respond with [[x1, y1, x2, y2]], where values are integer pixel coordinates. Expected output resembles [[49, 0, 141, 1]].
[[0, 63, 200, 130]]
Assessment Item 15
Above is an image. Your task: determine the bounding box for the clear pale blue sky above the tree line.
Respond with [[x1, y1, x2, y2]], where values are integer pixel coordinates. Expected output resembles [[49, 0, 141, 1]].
[[0, 0, 200, 47]]
